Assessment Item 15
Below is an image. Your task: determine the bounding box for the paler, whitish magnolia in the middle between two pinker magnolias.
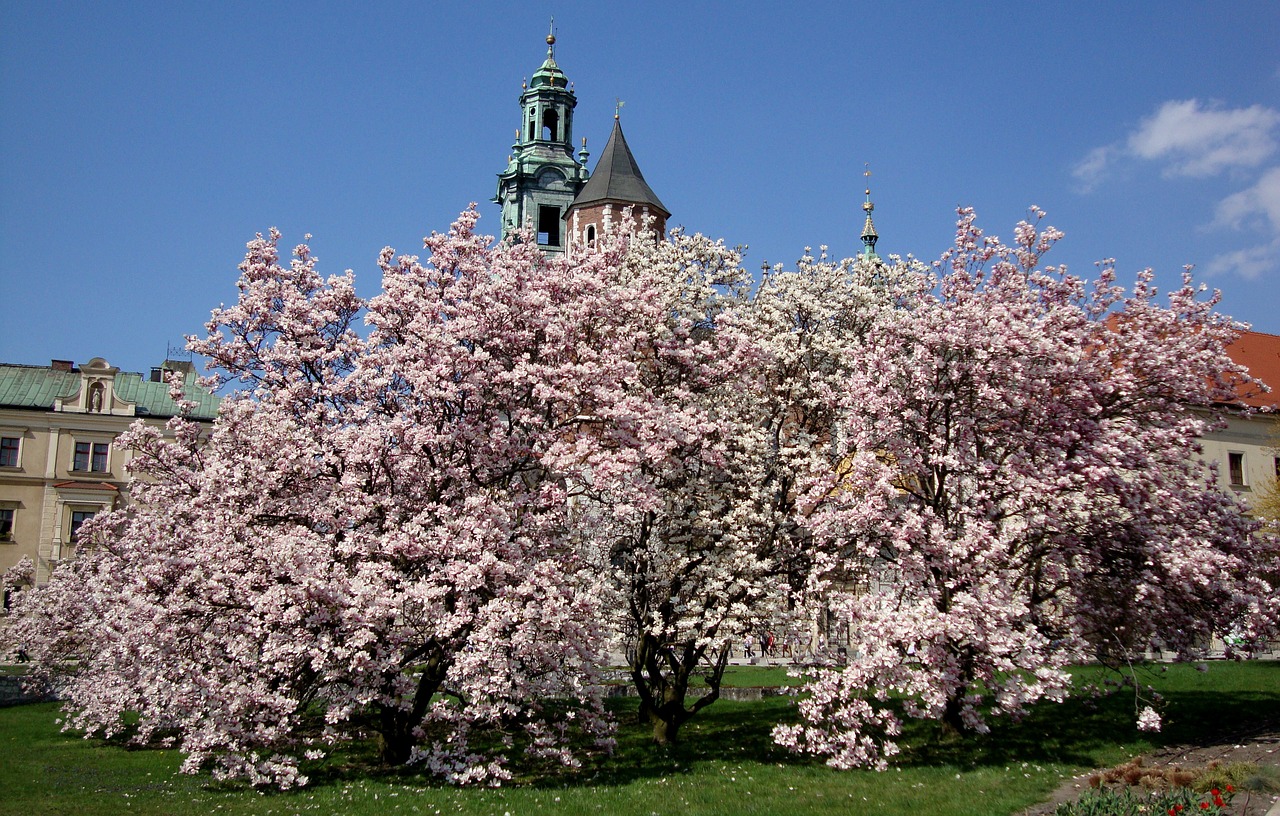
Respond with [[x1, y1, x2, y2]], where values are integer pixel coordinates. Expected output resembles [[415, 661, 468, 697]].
[[590, 223, 931, 743]]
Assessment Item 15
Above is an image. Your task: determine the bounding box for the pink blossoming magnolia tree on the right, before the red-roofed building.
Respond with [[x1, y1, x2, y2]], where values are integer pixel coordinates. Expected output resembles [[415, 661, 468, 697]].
[[774, 211, 1276, 767]]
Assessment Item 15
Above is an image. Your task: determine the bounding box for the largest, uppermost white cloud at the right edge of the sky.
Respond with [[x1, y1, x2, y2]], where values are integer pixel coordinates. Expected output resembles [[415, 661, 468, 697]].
[[1128, 100, 1280, 177]]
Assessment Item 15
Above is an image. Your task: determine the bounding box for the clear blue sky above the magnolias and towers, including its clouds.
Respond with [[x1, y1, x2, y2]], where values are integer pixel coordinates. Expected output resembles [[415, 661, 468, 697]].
[[0, 0, 1280, 371]]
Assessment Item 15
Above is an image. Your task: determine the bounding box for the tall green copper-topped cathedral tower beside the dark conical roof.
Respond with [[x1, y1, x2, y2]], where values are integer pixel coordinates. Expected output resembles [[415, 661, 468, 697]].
[[493, 33, 588, 255]]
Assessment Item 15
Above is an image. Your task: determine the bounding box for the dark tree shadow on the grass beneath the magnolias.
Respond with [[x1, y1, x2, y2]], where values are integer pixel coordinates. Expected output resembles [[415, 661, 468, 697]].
[[80, 663, 1280, 796]]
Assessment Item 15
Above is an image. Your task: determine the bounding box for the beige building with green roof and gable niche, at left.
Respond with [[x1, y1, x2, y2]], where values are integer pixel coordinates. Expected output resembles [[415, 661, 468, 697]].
[[0, 357, 219, 601]]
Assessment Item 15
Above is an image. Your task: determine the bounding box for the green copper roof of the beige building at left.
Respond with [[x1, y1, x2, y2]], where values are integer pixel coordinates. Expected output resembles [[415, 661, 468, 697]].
[[0, 363, 221, 420]]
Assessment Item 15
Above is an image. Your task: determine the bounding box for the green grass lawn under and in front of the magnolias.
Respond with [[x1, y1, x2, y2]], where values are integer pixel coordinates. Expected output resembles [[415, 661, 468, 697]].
[[0, 663, 1280, 816]]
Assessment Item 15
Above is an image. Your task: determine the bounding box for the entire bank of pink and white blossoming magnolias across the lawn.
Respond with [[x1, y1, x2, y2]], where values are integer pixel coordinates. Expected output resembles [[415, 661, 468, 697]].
[[6, 202, 1276, 787]]
